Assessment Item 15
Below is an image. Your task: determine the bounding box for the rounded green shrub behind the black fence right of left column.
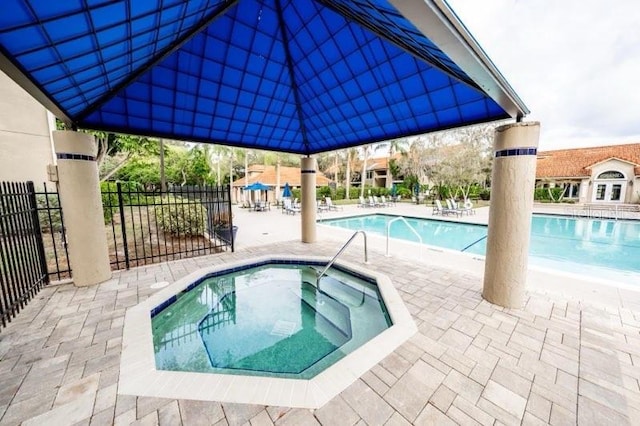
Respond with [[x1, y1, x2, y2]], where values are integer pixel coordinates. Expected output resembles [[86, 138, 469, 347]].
[[156, 195, 207, 236]]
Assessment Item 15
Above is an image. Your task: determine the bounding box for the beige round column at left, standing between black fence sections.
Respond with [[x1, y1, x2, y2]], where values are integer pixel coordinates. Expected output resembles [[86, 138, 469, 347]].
[[53, 131, 111, 286]]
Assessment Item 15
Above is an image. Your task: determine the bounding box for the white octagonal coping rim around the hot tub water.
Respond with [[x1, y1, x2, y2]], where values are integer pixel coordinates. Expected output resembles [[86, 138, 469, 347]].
[[118, 255, 417, 408]]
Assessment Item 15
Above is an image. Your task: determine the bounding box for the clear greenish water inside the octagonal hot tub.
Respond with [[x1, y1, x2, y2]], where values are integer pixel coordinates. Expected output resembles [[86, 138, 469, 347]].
[[152, 264, 391, 379]]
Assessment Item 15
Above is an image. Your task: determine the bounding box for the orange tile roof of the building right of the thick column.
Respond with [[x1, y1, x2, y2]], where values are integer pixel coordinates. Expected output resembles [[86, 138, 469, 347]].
[[536, 143, 640, 179]]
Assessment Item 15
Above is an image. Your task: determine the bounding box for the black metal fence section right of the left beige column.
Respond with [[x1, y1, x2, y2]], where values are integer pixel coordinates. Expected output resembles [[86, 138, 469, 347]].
[[102, 183, 234, 269]]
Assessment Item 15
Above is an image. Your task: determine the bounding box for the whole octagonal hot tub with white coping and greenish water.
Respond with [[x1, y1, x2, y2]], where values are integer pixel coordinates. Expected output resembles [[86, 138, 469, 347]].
[[119, 256, 416, 408]]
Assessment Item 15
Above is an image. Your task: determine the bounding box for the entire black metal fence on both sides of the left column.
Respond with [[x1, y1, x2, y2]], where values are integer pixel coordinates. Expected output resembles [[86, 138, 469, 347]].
[[0, 182, 236, 326]]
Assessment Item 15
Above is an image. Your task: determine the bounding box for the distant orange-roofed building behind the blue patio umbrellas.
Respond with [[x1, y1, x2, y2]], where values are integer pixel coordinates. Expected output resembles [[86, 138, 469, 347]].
[[231, 164, 332, 202]]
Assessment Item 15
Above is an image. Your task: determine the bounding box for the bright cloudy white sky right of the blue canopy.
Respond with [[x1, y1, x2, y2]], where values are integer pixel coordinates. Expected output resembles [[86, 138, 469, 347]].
[[448, 0, 640, 150]]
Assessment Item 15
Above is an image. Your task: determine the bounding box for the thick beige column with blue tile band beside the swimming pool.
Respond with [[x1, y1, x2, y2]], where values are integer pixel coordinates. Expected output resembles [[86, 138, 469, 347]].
[[482, 122, 540, 308]]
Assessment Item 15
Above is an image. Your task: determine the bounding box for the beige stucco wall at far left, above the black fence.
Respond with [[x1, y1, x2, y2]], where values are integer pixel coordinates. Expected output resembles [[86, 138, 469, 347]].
[[0, 72, 55, 186]]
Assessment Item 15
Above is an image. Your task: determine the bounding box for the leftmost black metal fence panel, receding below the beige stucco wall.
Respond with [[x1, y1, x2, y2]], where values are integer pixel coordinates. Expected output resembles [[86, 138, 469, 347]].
[[0, 182, 49, 326]]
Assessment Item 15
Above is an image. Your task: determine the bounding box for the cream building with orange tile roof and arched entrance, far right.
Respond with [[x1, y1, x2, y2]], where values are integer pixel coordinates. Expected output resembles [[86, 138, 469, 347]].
[[536, 143, 640, 203]]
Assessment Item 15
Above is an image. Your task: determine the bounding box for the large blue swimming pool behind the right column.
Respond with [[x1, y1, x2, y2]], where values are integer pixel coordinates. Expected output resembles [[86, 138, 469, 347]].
[[319, 214, 640, 285]]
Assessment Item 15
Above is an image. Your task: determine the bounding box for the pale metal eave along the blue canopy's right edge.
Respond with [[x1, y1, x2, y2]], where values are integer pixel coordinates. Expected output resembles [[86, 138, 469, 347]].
[[389, 0, 530, 118]]
